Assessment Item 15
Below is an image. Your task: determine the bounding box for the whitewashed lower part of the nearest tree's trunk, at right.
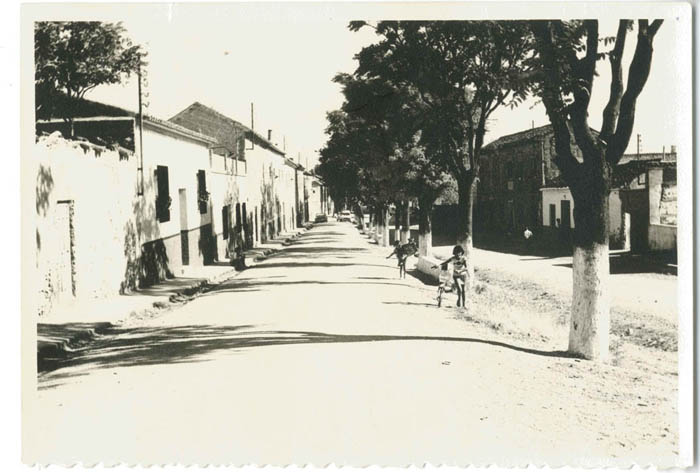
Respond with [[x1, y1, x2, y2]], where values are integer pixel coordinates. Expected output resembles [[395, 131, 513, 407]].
[[569, 243, 610, 361]]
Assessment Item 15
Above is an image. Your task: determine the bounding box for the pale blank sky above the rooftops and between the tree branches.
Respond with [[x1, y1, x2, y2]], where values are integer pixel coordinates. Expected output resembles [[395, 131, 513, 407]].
[[50, 4, 691, 166]]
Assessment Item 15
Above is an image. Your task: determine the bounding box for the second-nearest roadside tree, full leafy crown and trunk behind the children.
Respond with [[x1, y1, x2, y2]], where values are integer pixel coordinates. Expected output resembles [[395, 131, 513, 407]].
[[350, 21, 532, 286]]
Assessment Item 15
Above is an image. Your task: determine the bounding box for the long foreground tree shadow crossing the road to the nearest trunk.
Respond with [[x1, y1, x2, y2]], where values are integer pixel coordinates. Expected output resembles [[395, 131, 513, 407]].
[[39, 325, 584, 389]]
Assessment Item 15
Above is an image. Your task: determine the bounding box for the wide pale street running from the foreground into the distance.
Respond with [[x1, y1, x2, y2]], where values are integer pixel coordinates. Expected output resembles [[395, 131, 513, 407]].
[[25, 223, 678, 467]]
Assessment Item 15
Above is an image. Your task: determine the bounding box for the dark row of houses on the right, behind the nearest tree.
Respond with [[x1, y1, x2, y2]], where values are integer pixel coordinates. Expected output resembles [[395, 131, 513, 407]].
[[475, 125, 677, 252]]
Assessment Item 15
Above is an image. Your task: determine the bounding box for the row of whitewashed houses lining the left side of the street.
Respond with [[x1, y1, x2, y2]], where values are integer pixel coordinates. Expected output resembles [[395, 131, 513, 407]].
[[30, 100, 332, 313]]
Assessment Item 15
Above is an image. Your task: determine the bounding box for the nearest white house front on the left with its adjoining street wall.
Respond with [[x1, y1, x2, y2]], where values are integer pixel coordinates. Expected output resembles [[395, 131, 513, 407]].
[[32, 110, 221, 314]]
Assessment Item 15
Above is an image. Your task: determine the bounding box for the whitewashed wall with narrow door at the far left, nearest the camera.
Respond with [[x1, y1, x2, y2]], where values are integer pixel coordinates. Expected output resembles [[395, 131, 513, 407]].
[[33, 131, 139, 313]]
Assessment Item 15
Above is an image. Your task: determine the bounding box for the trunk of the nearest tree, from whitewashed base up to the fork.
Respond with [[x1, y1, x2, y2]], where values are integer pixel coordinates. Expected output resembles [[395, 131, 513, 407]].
[[569, 165, 610, 361]]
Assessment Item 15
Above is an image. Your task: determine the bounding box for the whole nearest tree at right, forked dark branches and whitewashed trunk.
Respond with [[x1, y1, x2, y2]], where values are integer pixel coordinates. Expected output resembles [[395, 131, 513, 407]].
[[531, 20, 662, 360]]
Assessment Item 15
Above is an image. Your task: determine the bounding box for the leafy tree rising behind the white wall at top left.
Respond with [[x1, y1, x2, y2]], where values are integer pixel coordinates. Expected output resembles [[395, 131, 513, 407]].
[[34, 21, 146, 135]]
